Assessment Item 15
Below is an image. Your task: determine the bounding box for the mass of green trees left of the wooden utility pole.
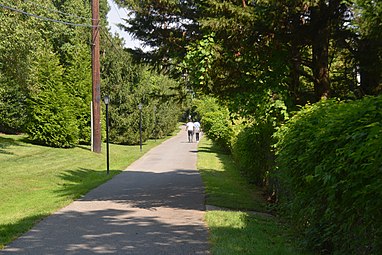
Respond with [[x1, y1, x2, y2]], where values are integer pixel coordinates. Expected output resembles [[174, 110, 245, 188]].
[[0, 0, 106, 147]]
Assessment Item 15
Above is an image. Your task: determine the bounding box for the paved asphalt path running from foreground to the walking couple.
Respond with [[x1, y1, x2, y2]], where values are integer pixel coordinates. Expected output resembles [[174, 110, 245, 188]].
[[0, 130, 209, 255]]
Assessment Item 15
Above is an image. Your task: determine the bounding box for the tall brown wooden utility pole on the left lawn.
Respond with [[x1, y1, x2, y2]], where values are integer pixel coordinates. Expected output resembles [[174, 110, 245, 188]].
[[92, 0, 101, 153]]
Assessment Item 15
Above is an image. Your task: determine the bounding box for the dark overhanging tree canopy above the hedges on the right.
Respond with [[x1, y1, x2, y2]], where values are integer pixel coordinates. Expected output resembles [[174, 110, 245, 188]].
[[117, 0, 381, 108]]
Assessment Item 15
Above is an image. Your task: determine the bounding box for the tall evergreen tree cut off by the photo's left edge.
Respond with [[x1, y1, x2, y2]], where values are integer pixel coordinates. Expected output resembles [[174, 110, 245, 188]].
[[0, 4, 35, 133]]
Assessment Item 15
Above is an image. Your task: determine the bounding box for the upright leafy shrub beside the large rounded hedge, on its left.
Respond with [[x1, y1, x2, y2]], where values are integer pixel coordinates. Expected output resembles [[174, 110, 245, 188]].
[[232, 91, 289, 189]]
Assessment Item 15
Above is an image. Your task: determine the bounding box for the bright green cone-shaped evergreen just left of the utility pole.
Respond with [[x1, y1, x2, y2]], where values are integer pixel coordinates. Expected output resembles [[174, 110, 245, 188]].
[[26, 46, 78, 147]]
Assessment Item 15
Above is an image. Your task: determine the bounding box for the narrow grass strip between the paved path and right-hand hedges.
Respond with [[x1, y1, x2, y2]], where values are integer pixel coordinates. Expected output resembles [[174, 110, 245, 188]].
[[198, 139, 309, 255]]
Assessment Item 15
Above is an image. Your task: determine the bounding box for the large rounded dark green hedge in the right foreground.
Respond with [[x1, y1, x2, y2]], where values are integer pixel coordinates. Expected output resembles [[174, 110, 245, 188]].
[[276, 96, 382, 254]]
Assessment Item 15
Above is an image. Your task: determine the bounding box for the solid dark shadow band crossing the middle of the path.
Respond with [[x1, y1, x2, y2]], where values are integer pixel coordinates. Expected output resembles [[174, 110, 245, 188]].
[[76, 169, 205, 210]]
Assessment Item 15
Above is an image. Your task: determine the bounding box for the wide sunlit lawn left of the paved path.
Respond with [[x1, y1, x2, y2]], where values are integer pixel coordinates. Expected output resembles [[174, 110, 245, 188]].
[[0, 134, 173, 249]]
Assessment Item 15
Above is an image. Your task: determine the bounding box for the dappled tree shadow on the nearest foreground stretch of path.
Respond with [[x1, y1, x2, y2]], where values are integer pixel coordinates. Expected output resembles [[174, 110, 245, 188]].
[[0, 209, 207, 255]]
